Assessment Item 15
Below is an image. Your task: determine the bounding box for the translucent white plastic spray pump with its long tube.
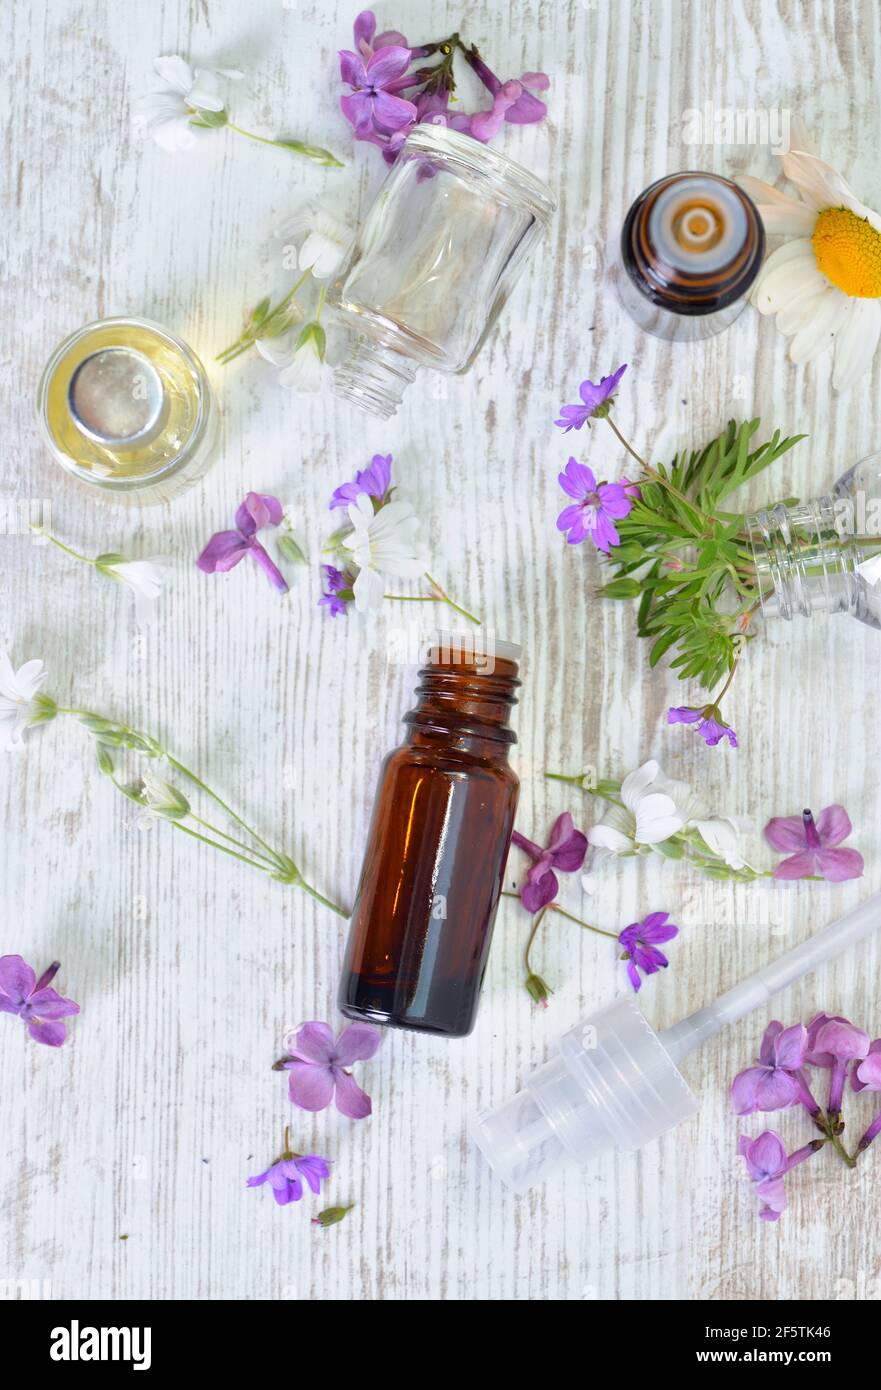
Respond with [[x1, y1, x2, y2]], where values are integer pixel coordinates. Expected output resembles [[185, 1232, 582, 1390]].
[[470, 892, 881, 1193]]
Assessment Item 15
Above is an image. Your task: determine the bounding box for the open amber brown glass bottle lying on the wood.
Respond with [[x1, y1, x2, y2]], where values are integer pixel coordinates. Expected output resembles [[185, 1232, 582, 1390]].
[[339, 638, 520, 1037]]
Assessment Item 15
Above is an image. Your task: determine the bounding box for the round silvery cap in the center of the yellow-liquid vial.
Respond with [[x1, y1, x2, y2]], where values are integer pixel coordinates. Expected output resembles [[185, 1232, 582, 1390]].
[[67, 348, 168, 449]]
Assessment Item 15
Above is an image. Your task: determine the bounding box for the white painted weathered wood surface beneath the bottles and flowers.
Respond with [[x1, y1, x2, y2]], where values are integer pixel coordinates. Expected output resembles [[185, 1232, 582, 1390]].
[[0, 0, 881, 1300]]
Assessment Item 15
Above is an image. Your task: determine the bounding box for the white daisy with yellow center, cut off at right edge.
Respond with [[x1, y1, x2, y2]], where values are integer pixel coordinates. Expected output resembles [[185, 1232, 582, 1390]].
[[739, 121, 881, 391]]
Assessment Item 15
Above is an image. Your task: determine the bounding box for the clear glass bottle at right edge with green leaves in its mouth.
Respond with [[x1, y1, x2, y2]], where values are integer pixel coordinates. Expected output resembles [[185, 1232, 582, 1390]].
[[746, 453, 881, 628]]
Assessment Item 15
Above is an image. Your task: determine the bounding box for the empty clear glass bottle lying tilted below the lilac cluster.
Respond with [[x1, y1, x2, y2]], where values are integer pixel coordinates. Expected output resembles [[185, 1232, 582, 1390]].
[[328, 124, 556, 420]]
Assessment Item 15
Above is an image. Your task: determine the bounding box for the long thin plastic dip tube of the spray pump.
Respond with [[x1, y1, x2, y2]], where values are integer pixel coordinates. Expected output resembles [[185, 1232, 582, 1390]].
[[660, 892, 881, 1062]]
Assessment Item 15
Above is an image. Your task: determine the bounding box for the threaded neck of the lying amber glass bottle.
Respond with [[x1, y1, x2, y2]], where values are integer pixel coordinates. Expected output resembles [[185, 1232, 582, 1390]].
[[404, 657, 520, 763]]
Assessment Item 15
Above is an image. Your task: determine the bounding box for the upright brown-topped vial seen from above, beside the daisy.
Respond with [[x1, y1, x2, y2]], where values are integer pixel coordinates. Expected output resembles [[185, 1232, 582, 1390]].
[[618, 172, 764, 342]]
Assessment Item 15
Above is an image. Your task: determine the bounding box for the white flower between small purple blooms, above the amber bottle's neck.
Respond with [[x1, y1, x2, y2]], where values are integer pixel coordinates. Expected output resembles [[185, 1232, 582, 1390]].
[[342, 492, 425, 613]]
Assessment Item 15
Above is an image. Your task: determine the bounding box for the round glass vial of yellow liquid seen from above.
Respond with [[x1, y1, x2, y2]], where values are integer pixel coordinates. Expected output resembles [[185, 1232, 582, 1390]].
[[38, 318, 218, 503]]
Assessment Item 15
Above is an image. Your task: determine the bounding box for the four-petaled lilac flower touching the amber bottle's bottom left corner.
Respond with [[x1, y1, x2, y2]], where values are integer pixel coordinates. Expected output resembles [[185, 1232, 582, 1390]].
[[277, 1023, 382, 1120]]
